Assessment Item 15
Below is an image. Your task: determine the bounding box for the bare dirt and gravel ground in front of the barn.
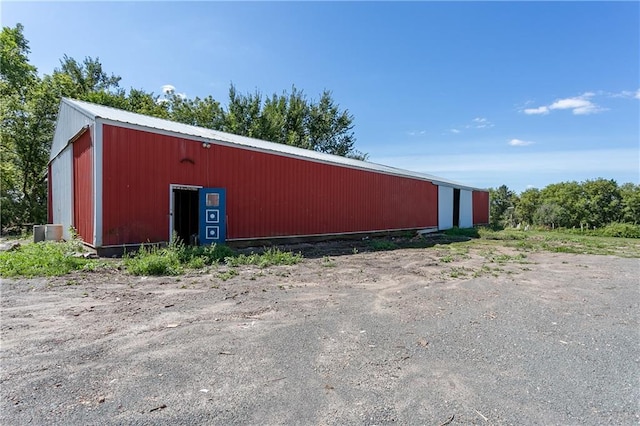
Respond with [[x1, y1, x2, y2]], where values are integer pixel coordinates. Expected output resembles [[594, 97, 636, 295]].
[[0, 243, 640, 425]]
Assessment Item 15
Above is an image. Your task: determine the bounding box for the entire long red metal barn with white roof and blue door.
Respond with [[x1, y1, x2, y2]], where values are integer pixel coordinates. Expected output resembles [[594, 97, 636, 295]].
[[48, 99, 489, 249]]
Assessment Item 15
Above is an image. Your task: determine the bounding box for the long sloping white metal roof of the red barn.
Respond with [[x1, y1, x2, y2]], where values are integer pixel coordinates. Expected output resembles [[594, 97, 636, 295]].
[[62, 98, 486, 191]]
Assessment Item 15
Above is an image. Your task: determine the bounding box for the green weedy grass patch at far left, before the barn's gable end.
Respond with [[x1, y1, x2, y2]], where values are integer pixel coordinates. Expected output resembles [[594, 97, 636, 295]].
[[0, 241, 98, 278]]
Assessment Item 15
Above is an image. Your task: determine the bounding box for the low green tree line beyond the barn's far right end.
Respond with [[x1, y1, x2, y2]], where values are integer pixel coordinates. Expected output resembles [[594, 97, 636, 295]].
[[489, 178, 640, 233]]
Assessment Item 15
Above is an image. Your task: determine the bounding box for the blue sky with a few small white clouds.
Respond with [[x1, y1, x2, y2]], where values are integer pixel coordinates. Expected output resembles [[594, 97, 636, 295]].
[[0, 2, 640, 192]]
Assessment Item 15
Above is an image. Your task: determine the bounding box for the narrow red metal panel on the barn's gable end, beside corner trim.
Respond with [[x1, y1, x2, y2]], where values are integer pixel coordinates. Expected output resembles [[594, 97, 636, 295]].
[[73, 132, 93, 244]]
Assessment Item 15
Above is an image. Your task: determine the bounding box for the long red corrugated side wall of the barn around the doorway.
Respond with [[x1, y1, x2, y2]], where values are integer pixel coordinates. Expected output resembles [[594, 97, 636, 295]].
[[103, 125, 438, 246]]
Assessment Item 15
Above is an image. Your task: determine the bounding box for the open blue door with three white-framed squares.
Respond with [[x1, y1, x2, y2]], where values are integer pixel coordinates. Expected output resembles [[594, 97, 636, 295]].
[[198, 188, 227, 245]]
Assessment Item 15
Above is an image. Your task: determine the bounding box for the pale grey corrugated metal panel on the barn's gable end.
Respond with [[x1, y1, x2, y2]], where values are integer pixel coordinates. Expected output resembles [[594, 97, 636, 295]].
[[51, 146, 73, 239]]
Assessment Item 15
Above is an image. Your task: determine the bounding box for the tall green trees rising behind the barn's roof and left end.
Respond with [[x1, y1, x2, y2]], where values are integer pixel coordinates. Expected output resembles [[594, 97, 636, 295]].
[[0, 24, 367, 231]]
